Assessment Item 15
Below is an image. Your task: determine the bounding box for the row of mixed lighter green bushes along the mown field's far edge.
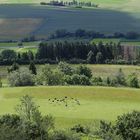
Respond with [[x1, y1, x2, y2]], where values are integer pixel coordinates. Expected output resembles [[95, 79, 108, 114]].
[[3, 62, 139, 88]]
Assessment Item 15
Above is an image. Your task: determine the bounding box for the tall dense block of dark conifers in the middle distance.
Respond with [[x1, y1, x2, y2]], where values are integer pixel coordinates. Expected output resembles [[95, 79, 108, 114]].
[[36, 41, 115, 63]]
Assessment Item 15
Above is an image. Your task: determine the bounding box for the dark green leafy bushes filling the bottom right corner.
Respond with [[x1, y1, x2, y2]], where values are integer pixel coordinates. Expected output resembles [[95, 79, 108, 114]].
[[99, 111, 140, 140]]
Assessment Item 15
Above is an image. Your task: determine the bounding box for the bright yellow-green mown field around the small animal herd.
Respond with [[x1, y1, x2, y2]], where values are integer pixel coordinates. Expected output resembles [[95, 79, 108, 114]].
[[0, 86, 140, 127]]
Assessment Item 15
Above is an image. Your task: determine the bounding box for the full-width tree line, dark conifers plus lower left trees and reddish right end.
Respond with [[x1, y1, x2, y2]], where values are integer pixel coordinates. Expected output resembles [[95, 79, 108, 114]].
[[0, 41, 140, 65]]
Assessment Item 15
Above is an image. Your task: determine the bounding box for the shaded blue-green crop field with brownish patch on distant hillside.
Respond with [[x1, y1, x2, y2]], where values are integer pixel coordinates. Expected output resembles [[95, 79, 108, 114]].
[[0, 5, 140, 40]]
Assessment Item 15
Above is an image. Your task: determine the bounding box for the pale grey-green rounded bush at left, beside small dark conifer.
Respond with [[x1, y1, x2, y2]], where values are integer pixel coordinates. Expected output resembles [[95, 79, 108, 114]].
[[8, 68, 35, 86]]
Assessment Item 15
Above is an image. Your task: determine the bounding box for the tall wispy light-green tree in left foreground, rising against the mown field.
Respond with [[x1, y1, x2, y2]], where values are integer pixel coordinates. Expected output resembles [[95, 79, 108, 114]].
[[16, 95, 54, 140]]
